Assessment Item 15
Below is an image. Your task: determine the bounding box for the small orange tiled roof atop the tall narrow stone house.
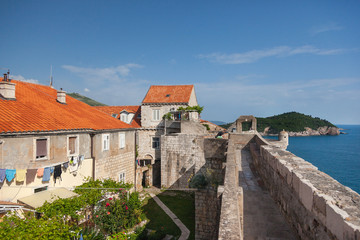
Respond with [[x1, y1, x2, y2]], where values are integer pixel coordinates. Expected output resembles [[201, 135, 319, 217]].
[[142, 85, 194, 103]]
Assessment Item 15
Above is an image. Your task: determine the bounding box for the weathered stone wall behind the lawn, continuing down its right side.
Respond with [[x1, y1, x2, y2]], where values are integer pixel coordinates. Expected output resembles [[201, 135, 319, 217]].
[[161, 134, 227, 240]]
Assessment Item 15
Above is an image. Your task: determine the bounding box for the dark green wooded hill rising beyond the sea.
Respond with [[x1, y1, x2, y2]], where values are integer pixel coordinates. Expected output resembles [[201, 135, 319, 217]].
[[221, 112, 336, 134]]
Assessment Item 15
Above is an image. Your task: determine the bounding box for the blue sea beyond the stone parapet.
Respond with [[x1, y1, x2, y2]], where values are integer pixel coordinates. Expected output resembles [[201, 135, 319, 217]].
[[264, 125, 360, 194]]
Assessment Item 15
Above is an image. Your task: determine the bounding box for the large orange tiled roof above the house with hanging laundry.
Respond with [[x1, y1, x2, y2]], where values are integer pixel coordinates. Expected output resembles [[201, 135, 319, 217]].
[[0, 78, 132, 133]]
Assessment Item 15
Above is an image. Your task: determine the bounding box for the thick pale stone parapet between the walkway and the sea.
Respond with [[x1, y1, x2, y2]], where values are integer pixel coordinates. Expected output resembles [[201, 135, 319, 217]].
[[250, 137, 360, 239]]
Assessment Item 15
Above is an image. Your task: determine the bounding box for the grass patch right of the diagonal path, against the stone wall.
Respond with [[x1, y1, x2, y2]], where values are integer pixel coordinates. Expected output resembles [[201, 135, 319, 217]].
[[157, 190, 195, 240]]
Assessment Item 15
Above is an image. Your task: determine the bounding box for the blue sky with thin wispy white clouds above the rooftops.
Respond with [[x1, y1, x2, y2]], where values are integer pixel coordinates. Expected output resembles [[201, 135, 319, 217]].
[[0, 0, 360, 124]]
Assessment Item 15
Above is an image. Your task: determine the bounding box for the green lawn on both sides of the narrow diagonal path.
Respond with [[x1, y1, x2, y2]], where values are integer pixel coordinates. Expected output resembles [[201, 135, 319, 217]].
[[144, 190, 195, 240]]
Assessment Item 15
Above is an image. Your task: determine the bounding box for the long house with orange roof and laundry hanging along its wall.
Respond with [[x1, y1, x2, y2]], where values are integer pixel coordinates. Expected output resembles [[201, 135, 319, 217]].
[[0, 75, 135, 202]]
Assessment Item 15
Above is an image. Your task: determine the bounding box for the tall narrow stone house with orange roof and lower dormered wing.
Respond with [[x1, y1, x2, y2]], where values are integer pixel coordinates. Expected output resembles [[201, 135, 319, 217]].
[[95, 85, 201, 190]]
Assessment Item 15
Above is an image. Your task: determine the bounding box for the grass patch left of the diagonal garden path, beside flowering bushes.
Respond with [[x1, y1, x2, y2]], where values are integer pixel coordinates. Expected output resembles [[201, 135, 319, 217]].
[[143, 197, 181, 238]]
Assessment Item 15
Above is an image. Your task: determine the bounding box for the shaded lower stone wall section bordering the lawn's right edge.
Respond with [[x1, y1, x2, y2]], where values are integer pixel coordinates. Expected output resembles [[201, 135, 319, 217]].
[[195, 190, 221, 240]]
